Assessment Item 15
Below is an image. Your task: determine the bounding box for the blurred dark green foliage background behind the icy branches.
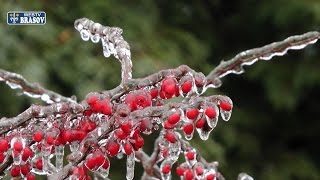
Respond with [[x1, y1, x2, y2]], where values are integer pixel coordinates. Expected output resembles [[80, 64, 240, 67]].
[[0, 0, 320, 180]]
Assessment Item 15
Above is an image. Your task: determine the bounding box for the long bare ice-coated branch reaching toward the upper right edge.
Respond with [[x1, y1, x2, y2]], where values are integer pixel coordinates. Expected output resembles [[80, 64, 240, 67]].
[[207, 31, 320, 88]]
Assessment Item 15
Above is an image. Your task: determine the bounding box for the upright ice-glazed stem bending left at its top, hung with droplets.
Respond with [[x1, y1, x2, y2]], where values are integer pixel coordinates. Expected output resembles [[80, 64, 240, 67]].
[[74, 18, 132, 85]]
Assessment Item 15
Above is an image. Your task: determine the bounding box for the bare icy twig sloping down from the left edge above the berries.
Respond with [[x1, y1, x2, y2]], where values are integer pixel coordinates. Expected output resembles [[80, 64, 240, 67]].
[[0, 69, 76, 104]]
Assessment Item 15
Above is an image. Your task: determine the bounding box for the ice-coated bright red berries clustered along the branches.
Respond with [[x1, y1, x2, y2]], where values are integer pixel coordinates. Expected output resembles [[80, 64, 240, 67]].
[[0, 74, 232, 180]]
